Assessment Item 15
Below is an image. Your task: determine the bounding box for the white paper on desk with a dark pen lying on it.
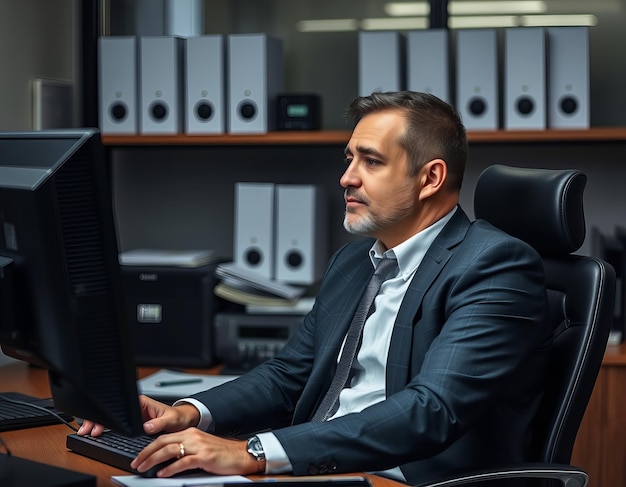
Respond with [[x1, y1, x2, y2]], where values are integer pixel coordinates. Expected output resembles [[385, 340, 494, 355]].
[[137, 369, 238, 399]]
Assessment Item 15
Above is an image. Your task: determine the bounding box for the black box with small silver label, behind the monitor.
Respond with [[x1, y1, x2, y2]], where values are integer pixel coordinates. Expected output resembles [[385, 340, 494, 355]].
[[122, 264, 225, 367]]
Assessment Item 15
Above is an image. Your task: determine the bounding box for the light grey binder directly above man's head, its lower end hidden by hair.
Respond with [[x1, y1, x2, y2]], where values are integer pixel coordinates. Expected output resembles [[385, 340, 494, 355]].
[[406, 29, 452, 103]]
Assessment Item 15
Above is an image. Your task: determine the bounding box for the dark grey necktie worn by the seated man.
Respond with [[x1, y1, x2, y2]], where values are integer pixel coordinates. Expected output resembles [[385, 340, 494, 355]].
[[311, 258, 397, 422]]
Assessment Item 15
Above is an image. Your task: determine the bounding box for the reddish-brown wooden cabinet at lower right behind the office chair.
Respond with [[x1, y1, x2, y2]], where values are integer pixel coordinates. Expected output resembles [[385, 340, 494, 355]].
[[572, 344, 626, 487]]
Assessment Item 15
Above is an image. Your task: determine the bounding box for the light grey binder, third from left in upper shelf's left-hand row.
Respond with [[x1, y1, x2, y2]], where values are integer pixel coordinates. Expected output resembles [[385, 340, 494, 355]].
[[184, 35, 226, 134]]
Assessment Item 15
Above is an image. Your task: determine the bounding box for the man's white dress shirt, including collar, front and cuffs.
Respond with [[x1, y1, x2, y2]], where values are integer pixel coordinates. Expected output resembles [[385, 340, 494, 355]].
[[174, 209, 456, 481]]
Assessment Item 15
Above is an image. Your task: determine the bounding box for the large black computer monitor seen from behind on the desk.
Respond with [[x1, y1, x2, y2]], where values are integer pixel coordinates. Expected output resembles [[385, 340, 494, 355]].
[[0, 129, 143, 435]]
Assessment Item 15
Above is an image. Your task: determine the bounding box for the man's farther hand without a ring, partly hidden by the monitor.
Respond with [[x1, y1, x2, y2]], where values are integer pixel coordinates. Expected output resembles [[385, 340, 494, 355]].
[[78, 395, 200, 436]]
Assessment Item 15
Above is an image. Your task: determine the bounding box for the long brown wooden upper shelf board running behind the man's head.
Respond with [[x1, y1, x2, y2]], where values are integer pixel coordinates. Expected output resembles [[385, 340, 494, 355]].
[[102, 127, 626, 146]]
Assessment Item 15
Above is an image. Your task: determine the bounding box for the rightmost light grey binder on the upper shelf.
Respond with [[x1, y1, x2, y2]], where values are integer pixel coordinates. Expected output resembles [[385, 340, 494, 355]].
[[547, 27, 590, 129]]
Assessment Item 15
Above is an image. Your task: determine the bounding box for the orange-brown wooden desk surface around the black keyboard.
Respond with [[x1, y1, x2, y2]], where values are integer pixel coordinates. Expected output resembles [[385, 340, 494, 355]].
[[0, 362, 404, 487]]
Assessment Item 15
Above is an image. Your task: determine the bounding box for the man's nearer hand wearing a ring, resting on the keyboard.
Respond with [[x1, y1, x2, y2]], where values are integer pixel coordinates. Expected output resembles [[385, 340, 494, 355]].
[[130, 428, 258, 477]]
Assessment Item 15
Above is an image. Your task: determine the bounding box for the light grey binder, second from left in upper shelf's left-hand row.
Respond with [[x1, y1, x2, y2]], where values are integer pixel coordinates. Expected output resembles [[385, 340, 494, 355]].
[[139, 36, 184, 135]]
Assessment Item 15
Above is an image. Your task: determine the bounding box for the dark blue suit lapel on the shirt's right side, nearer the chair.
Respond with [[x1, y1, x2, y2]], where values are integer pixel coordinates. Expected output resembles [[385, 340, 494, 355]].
[[386, 208, 470, 396]]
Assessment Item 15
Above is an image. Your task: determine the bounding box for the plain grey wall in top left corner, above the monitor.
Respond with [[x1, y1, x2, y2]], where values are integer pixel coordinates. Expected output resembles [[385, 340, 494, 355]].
[[0, 0, 73, 131]]
